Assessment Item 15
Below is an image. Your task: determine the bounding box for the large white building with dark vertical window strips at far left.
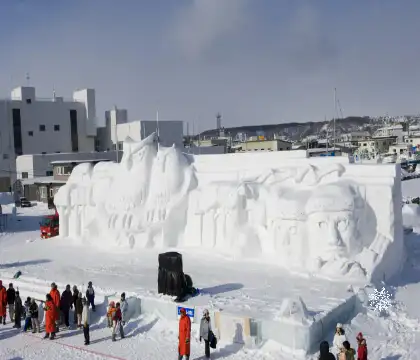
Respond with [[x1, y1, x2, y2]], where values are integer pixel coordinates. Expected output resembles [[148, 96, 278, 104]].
[[0, 87, 96, 191]]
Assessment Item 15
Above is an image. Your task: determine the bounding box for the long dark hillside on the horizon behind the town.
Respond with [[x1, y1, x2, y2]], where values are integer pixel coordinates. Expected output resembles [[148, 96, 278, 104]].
[[200, 116, 418, 141]]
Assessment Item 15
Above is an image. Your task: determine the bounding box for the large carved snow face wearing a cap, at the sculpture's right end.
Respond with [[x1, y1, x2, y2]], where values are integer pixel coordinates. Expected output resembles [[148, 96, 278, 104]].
[[305, 183, 363, 260]]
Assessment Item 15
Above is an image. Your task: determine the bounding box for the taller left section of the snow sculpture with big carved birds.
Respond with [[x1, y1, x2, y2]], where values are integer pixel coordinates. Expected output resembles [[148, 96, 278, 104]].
[[55, 134, 195, 247]]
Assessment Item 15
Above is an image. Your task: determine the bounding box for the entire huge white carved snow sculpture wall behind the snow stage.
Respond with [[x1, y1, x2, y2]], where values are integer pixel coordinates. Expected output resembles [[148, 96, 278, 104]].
[[55, 134, 404, 280]]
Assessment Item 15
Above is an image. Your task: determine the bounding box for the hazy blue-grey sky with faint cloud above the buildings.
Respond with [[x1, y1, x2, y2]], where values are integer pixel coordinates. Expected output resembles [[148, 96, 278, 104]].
[[0, 0, 420, 131]]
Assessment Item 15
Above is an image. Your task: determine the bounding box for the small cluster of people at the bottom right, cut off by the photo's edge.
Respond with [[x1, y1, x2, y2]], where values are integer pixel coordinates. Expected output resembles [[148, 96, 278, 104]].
[[319, 323, 368, 360]]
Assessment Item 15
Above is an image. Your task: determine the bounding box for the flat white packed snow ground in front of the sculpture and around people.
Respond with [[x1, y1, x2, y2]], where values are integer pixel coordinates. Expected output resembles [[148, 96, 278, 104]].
[[0, 179, 420, 360]]
